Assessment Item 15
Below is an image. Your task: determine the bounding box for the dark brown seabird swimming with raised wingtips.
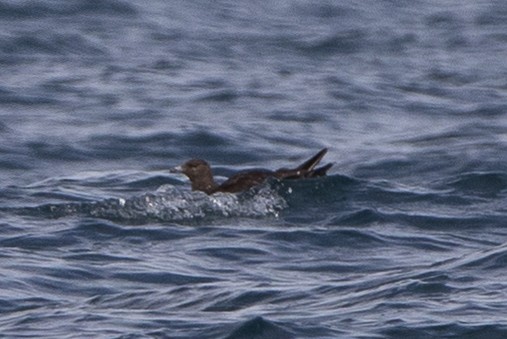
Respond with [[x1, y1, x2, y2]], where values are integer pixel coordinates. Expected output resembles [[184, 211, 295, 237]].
[[170, 148, 333, 194]]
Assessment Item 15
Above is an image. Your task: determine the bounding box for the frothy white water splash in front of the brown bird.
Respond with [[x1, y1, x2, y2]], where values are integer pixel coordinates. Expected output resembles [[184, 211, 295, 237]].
[[29, 184, 287, 223]]
